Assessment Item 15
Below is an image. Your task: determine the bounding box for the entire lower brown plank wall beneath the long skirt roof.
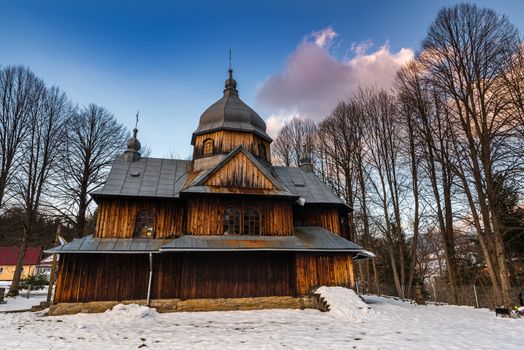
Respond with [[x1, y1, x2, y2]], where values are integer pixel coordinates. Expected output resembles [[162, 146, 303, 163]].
[[54, 252, 354, 303]]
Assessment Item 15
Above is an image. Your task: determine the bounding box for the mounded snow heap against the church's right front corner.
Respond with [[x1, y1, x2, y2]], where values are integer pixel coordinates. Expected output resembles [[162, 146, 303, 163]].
[[316, 287, 372, 322]]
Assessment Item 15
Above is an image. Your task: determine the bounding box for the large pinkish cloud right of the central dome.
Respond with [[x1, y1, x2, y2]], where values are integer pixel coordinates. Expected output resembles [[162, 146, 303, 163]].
[[257, 27, 414, 126]]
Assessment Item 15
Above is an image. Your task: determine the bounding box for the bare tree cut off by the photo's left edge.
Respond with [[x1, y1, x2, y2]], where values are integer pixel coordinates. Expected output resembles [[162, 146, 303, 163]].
[[0, 66, 44, 209]]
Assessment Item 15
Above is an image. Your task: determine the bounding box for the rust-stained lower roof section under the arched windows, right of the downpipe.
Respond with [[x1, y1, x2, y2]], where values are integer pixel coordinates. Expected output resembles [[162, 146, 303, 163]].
[[160, 226, 370, 253]]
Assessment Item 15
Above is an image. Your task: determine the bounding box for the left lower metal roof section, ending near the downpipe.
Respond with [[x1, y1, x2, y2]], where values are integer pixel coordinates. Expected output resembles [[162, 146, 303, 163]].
[[45, 235, 170, 254]]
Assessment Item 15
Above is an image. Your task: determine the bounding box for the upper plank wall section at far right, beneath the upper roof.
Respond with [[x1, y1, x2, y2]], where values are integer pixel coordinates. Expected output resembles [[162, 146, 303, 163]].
[[293, 204, 341, 235]]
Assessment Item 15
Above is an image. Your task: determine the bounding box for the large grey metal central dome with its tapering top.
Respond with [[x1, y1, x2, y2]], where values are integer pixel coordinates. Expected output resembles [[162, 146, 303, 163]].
[[191, 69, 272, 144]]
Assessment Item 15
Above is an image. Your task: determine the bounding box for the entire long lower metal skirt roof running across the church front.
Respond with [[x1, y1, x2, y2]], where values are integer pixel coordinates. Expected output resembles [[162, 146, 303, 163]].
[[45, 226, 372, 259]]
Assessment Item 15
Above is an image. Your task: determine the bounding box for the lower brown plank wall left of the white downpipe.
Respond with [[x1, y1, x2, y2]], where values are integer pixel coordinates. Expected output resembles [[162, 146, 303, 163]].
[[54, 254, 149, 303]]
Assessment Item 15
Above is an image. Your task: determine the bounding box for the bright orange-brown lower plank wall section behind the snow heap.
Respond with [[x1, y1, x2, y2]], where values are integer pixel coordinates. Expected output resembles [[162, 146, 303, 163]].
[[296, 253, 355, 295]]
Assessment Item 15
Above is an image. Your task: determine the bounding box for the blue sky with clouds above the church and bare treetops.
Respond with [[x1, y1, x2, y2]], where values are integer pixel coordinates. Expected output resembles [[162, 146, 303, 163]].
[[0, 0, 524, 158]]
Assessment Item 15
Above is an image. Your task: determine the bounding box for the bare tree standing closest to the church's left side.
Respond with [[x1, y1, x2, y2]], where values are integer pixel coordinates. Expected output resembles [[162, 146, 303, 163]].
[[53, 104, 127, 236]]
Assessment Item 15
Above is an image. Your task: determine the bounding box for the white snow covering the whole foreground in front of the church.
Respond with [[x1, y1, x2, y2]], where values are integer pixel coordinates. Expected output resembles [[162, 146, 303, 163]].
[[0, 287, 524, 350]]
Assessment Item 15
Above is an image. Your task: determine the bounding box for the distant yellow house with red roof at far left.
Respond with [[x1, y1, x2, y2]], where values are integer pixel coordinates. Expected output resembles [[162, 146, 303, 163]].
[[0, 247, 42, 282]]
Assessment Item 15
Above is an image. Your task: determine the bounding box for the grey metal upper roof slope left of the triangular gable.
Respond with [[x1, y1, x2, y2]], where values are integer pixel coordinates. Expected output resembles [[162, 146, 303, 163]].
[[91, 156, 191, 198]]
